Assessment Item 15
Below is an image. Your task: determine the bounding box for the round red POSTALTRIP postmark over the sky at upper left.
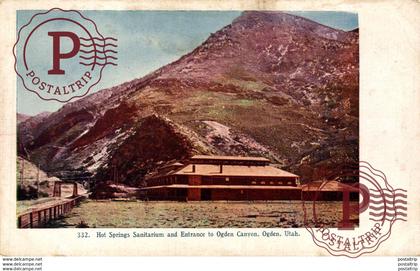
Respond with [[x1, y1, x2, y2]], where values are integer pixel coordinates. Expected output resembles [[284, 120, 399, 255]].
[[13, 8, 117, 103]]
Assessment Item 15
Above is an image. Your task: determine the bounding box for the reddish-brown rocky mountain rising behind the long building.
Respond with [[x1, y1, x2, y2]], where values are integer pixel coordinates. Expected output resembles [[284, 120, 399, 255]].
[[18, 12, 359, 185]]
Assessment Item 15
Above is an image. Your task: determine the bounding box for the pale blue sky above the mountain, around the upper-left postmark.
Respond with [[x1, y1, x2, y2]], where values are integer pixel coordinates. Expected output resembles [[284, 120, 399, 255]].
[[17, 10, 358, 115]]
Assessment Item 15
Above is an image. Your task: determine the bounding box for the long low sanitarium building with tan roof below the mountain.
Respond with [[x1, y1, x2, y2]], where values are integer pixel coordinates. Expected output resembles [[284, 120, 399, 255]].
[[140, 155, 301, 201]]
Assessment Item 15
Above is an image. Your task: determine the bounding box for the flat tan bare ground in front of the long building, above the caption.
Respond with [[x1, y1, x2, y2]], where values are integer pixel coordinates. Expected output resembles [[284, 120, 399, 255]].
[[49, 200, 358, 228]]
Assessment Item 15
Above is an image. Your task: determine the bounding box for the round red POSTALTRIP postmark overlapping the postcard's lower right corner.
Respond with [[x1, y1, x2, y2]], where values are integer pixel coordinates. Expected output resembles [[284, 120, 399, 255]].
[[302, 162, 407, 258]]
